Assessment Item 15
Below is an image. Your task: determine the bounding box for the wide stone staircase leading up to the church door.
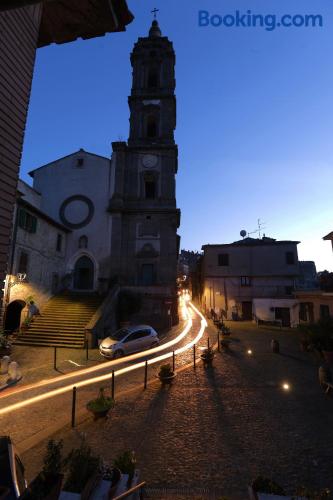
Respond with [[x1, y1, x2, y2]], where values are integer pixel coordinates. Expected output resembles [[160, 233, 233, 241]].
[[15, 292, 103, 348]]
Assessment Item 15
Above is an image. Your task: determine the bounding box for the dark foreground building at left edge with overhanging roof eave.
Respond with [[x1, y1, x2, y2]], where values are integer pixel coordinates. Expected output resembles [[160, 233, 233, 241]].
[[0, 0, 133, 325]]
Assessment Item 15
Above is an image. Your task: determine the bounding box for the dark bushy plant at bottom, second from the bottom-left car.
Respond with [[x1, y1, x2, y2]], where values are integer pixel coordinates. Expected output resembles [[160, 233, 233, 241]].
[[64, 439, 100, 500]]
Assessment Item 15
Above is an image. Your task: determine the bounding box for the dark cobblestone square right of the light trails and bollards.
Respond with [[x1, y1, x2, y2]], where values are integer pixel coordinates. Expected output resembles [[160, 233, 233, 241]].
[[19, 323, 333, 499]]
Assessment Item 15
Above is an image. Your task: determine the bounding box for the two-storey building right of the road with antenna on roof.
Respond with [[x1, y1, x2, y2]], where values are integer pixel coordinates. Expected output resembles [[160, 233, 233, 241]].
[[201, 237, 299, 324]]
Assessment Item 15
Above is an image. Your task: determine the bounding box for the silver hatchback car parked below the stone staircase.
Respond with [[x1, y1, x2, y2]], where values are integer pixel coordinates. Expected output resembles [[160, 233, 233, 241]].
[[99, 325, 160, 359]]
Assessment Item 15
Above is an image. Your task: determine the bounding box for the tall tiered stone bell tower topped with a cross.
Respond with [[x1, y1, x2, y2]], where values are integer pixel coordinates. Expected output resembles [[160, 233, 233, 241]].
[[109, 19, 180, 326]]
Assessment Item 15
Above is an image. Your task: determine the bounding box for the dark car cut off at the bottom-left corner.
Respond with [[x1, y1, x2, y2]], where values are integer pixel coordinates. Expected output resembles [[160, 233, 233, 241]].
[[0, 436, 27, 500]]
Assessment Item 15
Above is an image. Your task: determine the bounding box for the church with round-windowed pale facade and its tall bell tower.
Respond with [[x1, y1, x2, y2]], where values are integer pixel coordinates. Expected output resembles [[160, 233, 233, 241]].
[[5, 20, 180, 332]]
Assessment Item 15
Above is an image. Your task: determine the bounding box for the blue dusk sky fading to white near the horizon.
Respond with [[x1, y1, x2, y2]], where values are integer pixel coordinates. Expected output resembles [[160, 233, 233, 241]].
[[21, 0, 333, 270]]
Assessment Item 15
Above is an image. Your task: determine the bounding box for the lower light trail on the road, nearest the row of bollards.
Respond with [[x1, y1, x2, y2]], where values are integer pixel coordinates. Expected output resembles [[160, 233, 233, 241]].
[[0, 302, 207, 415]]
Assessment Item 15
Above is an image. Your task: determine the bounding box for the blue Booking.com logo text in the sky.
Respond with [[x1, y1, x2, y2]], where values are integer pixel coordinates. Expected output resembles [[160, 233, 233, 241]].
[[199, 10, 323, 31]]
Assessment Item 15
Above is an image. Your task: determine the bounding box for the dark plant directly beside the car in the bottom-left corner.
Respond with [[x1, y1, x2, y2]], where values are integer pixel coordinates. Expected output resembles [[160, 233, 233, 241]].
[[24, 439, 64, 500]]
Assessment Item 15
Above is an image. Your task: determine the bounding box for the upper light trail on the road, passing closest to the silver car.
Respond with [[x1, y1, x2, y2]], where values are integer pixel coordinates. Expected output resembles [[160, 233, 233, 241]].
[[0, 294, 192, 400]]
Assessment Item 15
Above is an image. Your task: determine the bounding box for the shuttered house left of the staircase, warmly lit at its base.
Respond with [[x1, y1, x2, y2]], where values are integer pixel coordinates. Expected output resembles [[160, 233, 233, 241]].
[[5, 180, 70, 331]]
